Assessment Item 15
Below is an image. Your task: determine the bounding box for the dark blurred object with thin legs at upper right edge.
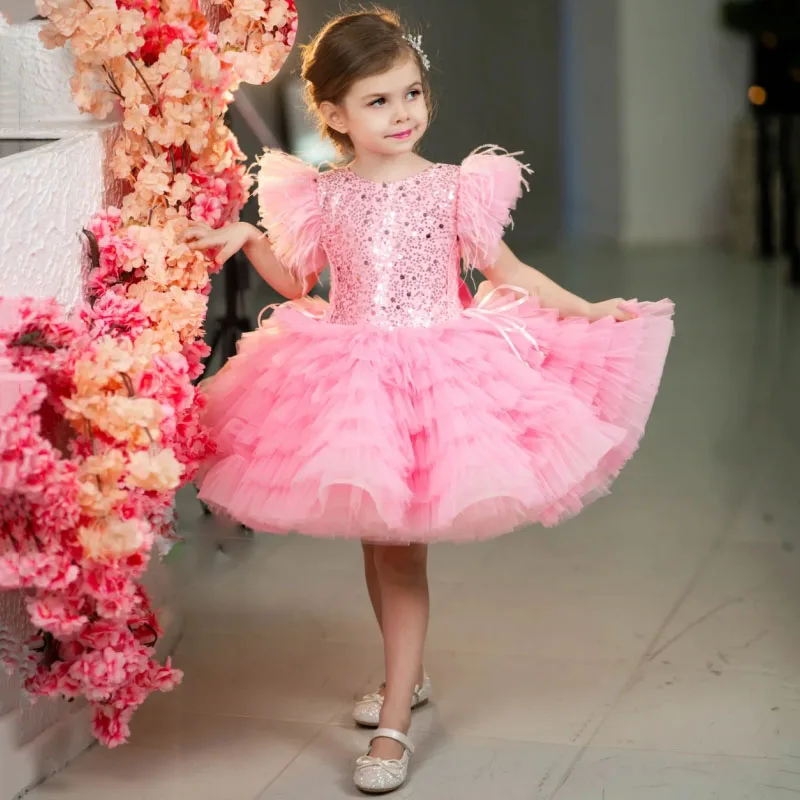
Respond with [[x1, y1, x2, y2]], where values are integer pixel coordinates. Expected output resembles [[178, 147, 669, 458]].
[[723, 0, 800, 285]]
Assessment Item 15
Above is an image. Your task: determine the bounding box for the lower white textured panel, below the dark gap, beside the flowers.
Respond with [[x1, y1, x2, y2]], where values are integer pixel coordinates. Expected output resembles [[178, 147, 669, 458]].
[[0, 127, 119, 308]]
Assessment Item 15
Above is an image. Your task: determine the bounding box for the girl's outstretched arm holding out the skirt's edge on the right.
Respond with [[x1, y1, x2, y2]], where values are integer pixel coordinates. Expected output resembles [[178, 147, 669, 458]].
[[484, 242, 634, 322]]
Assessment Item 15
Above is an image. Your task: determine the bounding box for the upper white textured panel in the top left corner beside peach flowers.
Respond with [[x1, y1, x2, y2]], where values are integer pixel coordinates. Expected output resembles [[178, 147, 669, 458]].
[[0, 20, 92, 132]]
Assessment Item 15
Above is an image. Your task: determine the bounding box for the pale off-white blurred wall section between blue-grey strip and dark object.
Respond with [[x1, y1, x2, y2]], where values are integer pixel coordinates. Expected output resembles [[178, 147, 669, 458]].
[[620, 0, 749, 242]]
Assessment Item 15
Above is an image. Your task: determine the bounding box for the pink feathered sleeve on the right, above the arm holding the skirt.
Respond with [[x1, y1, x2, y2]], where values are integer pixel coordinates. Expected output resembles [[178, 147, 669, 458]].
[[457, 146, 531, 270]]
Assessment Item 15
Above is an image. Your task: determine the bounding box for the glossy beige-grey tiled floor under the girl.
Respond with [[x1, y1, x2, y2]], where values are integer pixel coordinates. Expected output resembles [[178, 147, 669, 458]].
[[21, 250, 800, 800]]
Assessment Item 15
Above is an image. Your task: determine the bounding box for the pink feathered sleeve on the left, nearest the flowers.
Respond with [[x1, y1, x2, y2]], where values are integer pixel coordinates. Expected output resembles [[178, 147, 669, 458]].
[[256, 150, 327, 278]]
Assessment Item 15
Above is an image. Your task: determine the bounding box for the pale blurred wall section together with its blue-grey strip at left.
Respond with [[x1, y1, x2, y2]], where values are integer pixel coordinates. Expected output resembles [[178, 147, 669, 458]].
[[564, 0, 749, 244]]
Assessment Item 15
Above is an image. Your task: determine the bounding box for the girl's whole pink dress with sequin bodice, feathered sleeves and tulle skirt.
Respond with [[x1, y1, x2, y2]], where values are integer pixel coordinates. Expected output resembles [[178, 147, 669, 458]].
[[199, 150, 673, 543]]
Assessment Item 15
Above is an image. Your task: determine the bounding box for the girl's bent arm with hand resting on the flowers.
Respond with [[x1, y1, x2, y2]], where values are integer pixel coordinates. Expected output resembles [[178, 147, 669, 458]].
[[186, 222, 318, 300]]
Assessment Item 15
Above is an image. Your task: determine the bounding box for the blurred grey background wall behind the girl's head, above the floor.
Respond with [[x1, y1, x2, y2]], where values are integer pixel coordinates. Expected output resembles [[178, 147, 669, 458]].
[[227, 0, 752, 248]]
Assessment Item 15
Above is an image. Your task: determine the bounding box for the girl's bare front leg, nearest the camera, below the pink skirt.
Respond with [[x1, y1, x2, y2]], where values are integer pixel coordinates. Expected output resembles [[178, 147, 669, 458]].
[[371, 544, 430, 759]]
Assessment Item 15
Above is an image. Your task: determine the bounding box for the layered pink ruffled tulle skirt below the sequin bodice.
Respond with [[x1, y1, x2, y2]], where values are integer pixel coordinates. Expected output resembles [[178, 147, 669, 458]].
[[198, 299, 673, 543]]
